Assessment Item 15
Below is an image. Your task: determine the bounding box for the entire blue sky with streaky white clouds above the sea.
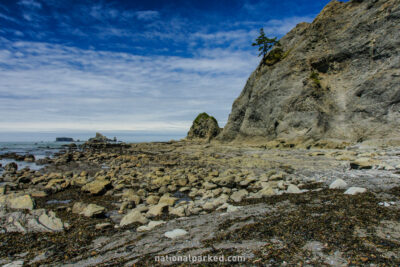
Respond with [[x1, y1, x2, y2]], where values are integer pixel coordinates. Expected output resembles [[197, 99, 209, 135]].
[[0, 0, 329, 132]]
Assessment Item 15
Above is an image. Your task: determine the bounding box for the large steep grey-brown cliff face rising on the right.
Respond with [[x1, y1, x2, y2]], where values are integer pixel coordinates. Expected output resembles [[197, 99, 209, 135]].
[[218, 0, 400, 146]]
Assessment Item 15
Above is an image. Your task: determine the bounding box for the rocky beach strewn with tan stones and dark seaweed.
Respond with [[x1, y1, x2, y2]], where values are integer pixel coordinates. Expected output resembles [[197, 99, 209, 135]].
[[0, 141, 400, 266]]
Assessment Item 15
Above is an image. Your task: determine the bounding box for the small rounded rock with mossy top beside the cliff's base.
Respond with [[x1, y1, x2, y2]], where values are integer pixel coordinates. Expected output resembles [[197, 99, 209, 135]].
[[187, 112, 221, 140]]
